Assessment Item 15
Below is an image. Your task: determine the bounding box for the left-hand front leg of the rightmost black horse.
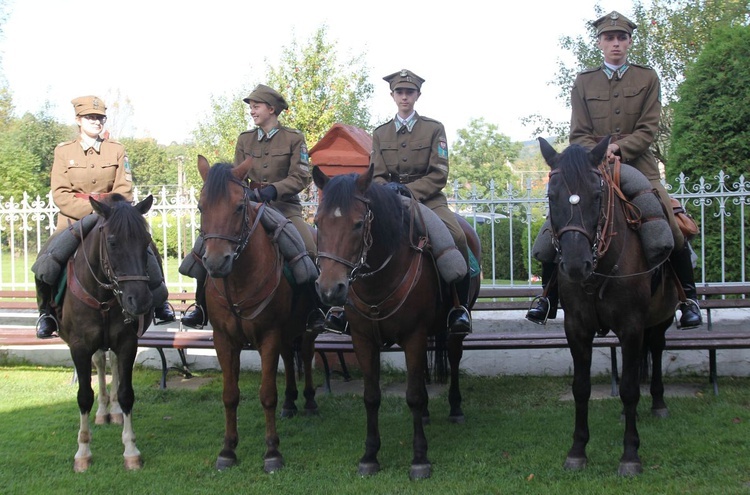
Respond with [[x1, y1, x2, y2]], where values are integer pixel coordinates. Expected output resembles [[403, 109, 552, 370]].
[[563, 338, 592, 470]]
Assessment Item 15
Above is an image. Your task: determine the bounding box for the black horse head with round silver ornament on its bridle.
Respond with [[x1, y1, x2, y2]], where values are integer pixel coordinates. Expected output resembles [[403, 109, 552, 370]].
[[539, 138, 609, 281]]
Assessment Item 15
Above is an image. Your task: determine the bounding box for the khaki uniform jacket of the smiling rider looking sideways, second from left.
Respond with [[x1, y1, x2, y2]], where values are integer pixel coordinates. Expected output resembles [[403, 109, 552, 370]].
[[234, 126, 310, 218]]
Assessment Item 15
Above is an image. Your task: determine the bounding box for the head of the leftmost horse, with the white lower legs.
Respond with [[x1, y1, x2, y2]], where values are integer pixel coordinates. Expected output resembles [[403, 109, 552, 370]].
[[87, 193, 154, 316]]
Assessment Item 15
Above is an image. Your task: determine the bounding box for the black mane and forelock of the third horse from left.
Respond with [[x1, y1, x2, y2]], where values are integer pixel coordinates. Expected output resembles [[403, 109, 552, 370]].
[[319, 174, 409, 248]]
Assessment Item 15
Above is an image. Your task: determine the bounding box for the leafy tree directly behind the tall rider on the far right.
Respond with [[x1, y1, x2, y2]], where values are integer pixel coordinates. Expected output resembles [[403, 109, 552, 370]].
[[536, 0, 750, 163]]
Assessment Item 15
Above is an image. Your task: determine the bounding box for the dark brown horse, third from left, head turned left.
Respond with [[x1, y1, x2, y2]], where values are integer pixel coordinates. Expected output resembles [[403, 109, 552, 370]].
[[313, 166, 480, 478]]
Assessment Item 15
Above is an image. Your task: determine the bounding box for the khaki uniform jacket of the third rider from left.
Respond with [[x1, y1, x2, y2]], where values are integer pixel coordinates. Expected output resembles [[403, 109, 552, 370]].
[[370, 114, 448, 209]]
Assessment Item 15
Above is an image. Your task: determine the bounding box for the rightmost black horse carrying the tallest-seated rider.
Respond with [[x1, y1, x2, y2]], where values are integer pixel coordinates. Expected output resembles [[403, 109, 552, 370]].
[[539, 139, 678, 475]]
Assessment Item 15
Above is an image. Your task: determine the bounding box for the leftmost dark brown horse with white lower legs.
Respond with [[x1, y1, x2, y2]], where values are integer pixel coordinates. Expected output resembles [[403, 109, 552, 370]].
[[60, 194, 153, 472]]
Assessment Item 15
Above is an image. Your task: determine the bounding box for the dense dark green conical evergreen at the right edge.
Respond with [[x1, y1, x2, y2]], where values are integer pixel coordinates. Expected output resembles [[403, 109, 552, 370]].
[[666, 25, 750, 280]]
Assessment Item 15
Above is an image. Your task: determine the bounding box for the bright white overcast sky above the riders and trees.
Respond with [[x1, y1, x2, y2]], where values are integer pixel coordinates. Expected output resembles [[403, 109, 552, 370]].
[[0, 0, 632, 144]]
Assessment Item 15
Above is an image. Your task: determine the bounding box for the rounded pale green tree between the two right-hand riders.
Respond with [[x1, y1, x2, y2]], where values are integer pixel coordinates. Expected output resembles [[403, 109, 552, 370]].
[[448, 118, 523, 194]]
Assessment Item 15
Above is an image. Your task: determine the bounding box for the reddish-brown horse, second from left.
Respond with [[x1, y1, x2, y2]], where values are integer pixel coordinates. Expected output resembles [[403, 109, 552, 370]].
[[198, 156, 318, 473]]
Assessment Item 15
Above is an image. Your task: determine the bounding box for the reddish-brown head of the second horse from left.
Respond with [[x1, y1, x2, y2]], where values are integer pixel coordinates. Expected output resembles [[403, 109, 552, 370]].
[[198, 156, 252, 278]]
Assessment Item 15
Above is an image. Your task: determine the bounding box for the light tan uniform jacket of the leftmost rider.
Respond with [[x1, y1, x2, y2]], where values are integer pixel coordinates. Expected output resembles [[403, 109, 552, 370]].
[[51, 137, 133, 231]]
